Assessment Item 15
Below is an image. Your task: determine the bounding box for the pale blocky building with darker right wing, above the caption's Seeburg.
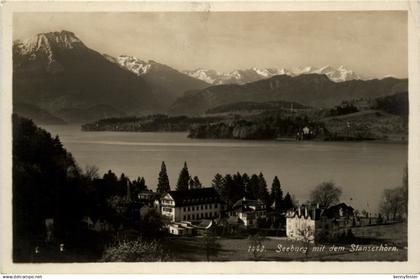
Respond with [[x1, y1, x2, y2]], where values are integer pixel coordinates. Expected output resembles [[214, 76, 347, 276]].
[[286, 203, 355, 241]]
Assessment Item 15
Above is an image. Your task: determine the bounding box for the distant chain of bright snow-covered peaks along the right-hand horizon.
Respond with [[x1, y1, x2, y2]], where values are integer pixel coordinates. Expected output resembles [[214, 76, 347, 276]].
[[184, 66, 361, 85]]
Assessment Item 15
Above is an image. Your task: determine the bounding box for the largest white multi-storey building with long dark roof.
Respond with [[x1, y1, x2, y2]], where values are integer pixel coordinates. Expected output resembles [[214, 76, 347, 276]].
[[160, 188, 222, 222]]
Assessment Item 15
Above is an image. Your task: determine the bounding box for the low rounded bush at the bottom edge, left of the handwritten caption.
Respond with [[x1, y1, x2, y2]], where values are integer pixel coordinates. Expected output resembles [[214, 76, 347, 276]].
[[101, 239, 170, 262]]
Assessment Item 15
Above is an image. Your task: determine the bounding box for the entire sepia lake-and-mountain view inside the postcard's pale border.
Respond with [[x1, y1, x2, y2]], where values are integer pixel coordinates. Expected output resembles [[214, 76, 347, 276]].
[[1, 1, 416, 274]]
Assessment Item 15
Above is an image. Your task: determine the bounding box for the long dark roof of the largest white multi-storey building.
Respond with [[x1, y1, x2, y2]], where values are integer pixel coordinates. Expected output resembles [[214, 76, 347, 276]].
[[168, 187, 220, 206]]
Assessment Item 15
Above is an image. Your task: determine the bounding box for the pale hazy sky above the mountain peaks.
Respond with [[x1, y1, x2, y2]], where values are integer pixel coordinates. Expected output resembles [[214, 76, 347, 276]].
[[13, 11, 408, 78]]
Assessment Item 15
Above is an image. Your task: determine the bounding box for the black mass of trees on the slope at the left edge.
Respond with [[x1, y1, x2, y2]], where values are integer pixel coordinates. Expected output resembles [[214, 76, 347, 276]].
[[12, 114, 86, 262]]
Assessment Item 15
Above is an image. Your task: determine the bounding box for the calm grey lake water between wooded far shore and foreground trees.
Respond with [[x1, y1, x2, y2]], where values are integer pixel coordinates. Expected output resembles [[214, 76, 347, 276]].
[[44, 126, 407, 211]]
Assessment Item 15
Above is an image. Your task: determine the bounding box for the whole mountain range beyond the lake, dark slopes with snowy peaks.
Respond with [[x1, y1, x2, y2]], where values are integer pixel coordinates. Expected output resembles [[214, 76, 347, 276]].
[[13, 31, 408, 124]]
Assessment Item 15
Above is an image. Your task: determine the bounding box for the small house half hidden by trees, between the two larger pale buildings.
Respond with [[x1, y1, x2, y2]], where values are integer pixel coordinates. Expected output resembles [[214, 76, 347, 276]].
[[229, 197, 267, 228]]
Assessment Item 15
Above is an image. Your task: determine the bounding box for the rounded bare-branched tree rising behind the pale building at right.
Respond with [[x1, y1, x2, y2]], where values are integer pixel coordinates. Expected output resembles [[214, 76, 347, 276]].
[[310, 181, 342, 208]]
